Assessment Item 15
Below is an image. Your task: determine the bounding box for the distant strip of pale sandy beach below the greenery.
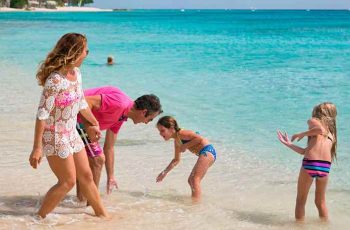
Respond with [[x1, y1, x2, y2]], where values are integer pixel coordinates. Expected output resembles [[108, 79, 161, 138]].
[[0, 6, 113, 12]]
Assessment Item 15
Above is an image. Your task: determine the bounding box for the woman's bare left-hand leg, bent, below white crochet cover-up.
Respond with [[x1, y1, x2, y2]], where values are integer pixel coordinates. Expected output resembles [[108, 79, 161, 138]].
[[38, 155, 76, 218]]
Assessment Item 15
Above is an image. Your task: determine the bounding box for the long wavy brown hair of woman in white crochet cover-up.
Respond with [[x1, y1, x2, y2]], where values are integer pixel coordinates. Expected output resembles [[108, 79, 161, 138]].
[[36, 33, 87, 86]]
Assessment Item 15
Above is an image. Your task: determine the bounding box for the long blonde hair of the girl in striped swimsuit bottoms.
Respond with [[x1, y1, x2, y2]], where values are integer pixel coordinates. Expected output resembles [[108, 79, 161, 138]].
[[312, 102, 337, 161]]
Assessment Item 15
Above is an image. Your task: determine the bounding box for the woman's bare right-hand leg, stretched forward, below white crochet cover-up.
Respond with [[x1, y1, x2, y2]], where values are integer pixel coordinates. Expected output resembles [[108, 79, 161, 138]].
[[74, 149, 107, 217]]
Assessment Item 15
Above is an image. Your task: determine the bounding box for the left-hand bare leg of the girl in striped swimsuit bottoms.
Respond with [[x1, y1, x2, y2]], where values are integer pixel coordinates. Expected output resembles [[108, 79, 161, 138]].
[[295, 168, 313, 221]]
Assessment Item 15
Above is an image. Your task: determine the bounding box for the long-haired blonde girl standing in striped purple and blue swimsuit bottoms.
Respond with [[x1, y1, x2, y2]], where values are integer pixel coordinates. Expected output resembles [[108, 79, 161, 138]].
[[277, 102, 337, 221]]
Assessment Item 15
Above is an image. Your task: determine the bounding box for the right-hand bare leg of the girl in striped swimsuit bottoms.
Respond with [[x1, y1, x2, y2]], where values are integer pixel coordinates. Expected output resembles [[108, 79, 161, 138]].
[[315, 176, 328, 220]]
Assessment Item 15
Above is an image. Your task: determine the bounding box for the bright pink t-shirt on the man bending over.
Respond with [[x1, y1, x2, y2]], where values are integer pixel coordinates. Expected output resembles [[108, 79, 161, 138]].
[[78, 86, 134, 134]]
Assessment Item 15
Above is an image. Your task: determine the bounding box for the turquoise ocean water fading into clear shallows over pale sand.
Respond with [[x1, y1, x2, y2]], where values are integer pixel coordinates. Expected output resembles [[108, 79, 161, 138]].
[[0, 10, 350, 229]]
